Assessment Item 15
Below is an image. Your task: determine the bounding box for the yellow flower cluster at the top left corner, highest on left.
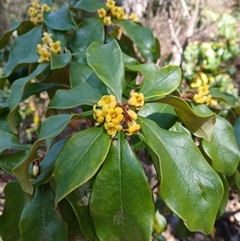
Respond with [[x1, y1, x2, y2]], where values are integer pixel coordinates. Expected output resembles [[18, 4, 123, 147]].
[[28, 0, 51, 25]]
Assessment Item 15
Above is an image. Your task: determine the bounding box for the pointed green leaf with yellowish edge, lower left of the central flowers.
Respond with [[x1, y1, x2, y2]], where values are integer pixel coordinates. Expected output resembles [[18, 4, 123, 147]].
[[54, 127, 111, 203]]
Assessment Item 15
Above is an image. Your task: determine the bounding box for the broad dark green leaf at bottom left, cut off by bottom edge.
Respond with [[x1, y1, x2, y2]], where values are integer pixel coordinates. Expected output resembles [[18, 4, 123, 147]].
[[19, 184, 67, 241]]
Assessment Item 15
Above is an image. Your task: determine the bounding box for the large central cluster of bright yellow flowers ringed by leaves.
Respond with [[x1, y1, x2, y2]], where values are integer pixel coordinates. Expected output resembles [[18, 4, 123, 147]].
[[93, 92, 144, 136]]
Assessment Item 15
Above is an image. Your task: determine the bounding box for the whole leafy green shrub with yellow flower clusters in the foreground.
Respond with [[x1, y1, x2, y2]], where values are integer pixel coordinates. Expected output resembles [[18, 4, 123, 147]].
[[0, 0, 240, 241]]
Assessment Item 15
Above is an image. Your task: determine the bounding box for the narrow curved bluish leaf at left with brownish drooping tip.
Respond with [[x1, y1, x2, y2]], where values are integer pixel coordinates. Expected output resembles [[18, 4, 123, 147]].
[[7, 63, 48, 133]]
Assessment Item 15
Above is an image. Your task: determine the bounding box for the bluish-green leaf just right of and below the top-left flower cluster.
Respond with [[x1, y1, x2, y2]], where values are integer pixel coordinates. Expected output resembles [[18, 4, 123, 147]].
[[43, 2, 77, 31]]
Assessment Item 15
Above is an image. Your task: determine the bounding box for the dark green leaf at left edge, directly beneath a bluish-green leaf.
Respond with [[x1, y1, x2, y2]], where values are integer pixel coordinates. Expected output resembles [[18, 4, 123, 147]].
[[0, 151, 27, 174]]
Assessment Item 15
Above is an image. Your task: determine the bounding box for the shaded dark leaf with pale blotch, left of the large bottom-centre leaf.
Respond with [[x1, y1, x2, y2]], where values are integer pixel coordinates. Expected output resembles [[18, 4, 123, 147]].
[[66, 182, 98, 241]]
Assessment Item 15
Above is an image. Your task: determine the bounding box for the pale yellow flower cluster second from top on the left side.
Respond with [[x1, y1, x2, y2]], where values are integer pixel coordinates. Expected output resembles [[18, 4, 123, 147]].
[[36, 32, 62, 63]]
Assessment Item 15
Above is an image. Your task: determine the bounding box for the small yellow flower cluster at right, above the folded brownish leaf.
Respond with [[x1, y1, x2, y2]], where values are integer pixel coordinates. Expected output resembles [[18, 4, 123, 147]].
[[193, 85, 217, 107]]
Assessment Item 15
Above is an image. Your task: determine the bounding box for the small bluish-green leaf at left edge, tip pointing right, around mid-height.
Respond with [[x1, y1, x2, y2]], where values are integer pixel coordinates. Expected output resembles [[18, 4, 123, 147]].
[[0, 130, 31, 153]]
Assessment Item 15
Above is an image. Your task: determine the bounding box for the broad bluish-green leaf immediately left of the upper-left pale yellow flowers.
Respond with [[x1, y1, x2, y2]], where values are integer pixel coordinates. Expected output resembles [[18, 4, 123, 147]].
[[3, 25, 42, 77]]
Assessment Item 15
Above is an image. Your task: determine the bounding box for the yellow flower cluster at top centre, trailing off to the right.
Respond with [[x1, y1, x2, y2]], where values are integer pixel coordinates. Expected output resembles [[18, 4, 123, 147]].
[[98, 0, 138, 25]]
